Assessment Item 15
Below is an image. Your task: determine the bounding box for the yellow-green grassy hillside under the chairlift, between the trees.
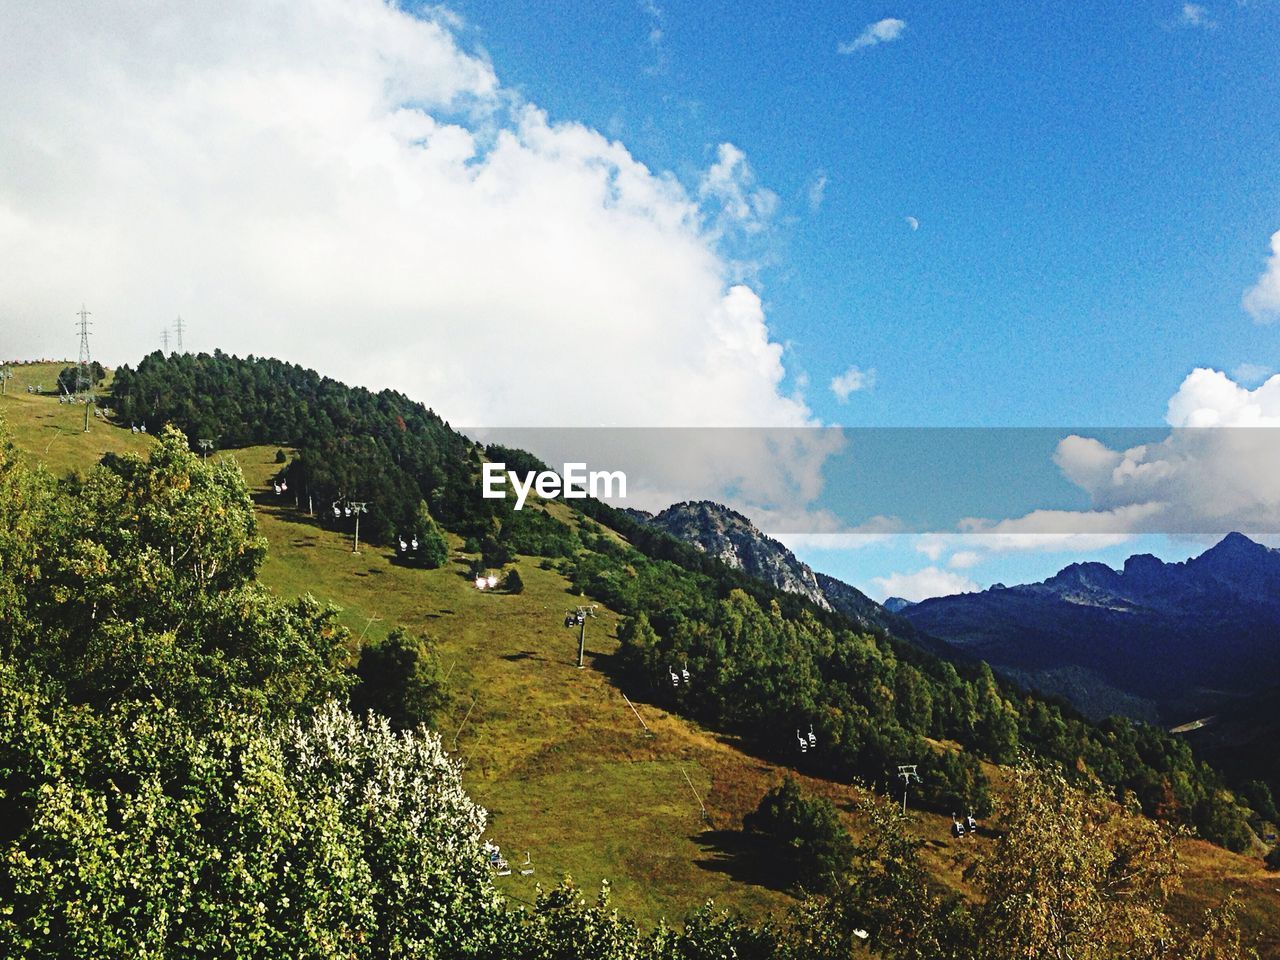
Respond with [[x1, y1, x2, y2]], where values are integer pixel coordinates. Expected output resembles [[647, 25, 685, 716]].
[[0, 366, 1280, 956]]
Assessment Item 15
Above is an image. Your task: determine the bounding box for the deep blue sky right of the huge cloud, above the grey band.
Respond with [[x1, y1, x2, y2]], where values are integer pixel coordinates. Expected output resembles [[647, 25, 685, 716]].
[[457, 0, 1280, 425]]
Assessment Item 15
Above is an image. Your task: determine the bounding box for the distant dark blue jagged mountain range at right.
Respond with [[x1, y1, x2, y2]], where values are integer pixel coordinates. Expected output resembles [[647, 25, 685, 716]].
[[901, 534, 1280, 723]]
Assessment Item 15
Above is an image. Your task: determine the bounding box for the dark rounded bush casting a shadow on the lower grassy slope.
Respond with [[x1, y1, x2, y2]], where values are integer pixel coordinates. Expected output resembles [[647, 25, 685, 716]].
[[742, 777, 854, 892]]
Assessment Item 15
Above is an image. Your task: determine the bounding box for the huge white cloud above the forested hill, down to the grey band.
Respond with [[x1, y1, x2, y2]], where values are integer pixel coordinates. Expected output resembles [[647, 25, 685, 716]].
[[0, 0, 813, 435]]
